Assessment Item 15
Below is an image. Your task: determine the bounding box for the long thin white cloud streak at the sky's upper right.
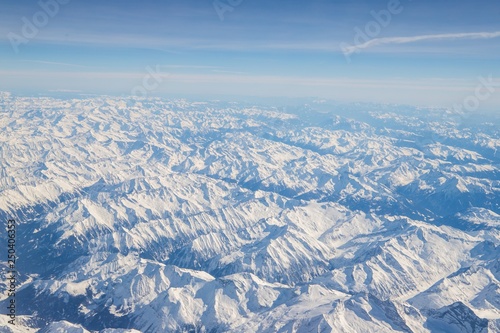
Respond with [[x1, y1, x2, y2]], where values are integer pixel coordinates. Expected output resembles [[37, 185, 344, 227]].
[[342, 31, 500, 55]]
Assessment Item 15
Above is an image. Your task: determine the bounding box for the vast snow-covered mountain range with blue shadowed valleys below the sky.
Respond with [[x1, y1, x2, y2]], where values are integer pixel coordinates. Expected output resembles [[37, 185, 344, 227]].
[[0, 93, 500, 333]]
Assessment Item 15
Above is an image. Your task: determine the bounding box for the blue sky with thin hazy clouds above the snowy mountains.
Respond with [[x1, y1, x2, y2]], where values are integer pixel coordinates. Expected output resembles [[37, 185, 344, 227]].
[[0, 0, 500, 109]]
